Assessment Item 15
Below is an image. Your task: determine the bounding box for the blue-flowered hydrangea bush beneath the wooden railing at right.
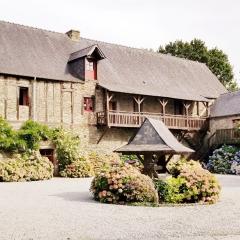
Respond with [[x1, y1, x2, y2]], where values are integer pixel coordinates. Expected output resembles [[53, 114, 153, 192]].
[[207, 145, 238, 174]]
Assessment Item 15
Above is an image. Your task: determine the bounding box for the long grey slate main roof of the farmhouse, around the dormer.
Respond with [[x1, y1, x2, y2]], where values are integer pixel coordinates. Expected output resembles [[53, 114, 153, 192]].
[[0, 21, 226, 101]]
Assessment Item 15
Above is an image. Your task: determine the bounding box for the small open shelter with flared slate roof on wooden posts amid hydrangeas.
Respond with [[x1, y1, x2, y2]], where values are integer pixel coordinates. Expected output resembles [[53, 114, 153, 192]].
[[115, 118, 194, 177]]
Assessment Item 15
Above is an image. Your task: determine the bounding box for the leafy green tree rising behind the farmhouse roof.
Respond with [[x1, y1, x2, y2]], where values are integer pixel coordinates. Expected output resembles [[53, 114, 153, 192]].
[[158, 39, 238, 91]]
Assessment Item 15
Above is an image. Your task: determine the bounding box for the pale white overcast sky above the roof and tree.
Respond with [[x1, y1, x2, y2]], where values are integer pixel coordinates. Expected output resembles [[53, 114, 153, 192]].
[[0, 0, 240, 82]]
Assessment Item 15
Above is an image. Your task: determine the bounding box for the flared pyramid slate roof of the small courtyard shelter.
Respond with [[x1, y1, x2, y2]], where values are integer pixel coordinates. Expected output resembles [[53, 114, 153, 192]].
[[115, 118, 194, 154]]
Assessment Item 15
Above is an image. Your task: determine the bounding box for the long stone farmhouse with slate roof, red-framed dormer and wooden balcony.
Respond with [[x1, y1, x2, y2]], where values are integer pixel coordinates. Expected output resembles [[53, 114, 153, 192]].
[[0, 21, 227, 156]]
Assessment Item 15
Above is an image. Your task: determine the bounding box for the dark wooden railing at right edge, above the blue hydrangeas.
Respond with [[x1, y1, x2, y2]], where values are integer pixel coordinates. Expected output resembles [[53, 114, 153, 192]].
[[209, 128, 240, 146]]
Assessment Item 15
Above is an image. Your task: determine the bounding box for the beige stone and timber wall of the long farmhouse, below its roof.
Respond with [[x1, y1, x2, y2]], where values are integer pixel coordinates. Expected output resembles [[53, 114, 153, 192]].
[[0, 75, 211, 153]]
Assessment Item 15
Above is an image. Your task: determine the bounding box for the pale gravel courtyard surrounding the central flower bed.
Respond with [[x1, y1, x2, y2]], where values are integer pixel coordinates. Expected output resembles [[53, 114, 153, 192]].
[[0, 176, 240, 240]]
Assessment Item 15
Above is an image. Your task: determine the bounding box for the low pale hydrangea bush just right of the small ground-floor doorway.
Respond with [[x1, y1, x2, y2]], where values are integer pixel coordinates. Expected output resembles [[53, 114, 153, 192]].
[[59, 157, 94, 178]]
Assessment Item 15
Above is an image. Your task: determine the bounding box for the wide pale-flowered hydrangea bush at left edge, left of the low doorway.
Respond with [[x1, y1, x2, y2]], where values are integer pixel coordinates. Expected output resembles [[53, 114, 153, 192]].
[[0, 152, 53, 182]]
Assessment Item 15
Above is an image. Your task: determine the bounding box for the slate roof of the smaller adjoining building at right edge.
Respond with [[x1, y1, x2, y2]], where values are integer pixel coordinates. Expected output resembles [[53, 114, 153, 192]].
[[210, 91, 240, 118]]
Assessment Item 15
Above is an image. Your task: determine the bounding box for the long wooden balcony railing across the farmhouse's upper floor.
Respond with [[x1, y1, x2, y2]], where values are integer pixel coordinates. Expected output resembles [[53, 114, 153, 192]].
[[97, 111, 206, 130]]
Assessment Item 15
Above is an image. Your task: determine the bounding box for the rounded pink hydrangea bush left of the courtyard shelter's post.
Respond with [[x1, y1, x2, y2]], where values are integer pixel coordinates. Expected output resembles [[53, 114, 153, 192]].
[[91, 164, 158, 205]]
